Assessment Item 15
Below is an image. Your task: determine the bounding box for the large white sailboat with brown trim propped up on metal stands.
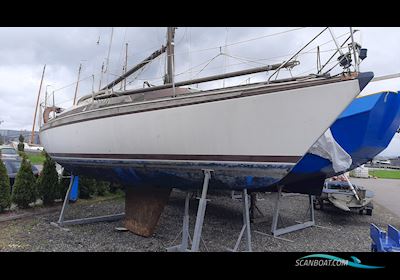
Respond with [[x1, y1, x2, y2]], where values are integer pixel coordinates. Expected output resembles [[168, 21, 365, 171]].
[[40, 28, 373, 235]]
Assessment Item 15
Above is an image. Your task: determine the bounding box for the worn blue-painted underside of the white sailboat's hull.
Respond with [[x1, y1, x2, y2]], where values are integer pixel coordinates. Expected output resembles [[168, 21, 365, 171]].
[[54, 157, 294, 190]]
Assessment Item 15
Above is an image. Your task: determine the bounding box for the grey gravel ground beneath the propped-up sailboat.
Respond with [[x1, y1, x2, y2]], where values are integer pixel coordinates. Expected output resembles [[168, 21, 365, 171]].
[[0, 191, 400, 252]]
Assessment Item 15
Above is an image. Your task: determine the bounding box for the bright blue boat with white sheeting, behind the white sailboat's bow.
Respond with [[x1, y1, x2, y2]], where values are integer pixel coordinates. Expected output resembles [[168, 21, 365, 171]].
[[279, 87, 400, 195]]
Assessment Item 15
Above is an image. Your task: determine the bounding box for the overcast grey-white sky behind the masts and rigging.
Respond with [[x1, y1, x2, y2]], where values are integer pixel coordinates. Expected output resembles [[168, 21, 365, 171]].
[[0, 27, 400, 136]]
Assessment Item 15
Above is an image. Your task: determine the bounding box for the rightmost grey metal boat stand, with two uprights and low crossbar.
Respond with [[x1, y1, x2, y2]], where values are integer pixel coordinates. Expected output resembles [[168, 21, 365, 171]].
[[252, 186, 316, 241]]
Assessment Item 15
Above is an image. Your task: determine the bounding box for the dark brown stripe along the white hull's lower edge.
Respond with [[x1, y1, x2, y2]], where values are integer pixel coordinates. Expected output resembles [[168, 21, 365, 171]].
[[49, 153, 301, 163]]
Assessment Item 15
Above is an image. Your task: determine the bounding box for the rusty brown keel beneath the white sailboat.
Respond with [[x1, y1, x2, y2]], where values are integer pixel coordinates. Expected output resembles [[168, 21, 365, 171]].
[[124, 186, 172, 237]]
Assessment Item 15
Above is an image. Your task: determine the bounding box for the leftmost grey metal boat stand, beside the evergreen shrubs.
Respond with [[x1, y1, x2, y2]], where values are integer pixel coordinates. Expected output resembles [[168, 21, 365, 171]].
[[50, 175, 125, 228]]
